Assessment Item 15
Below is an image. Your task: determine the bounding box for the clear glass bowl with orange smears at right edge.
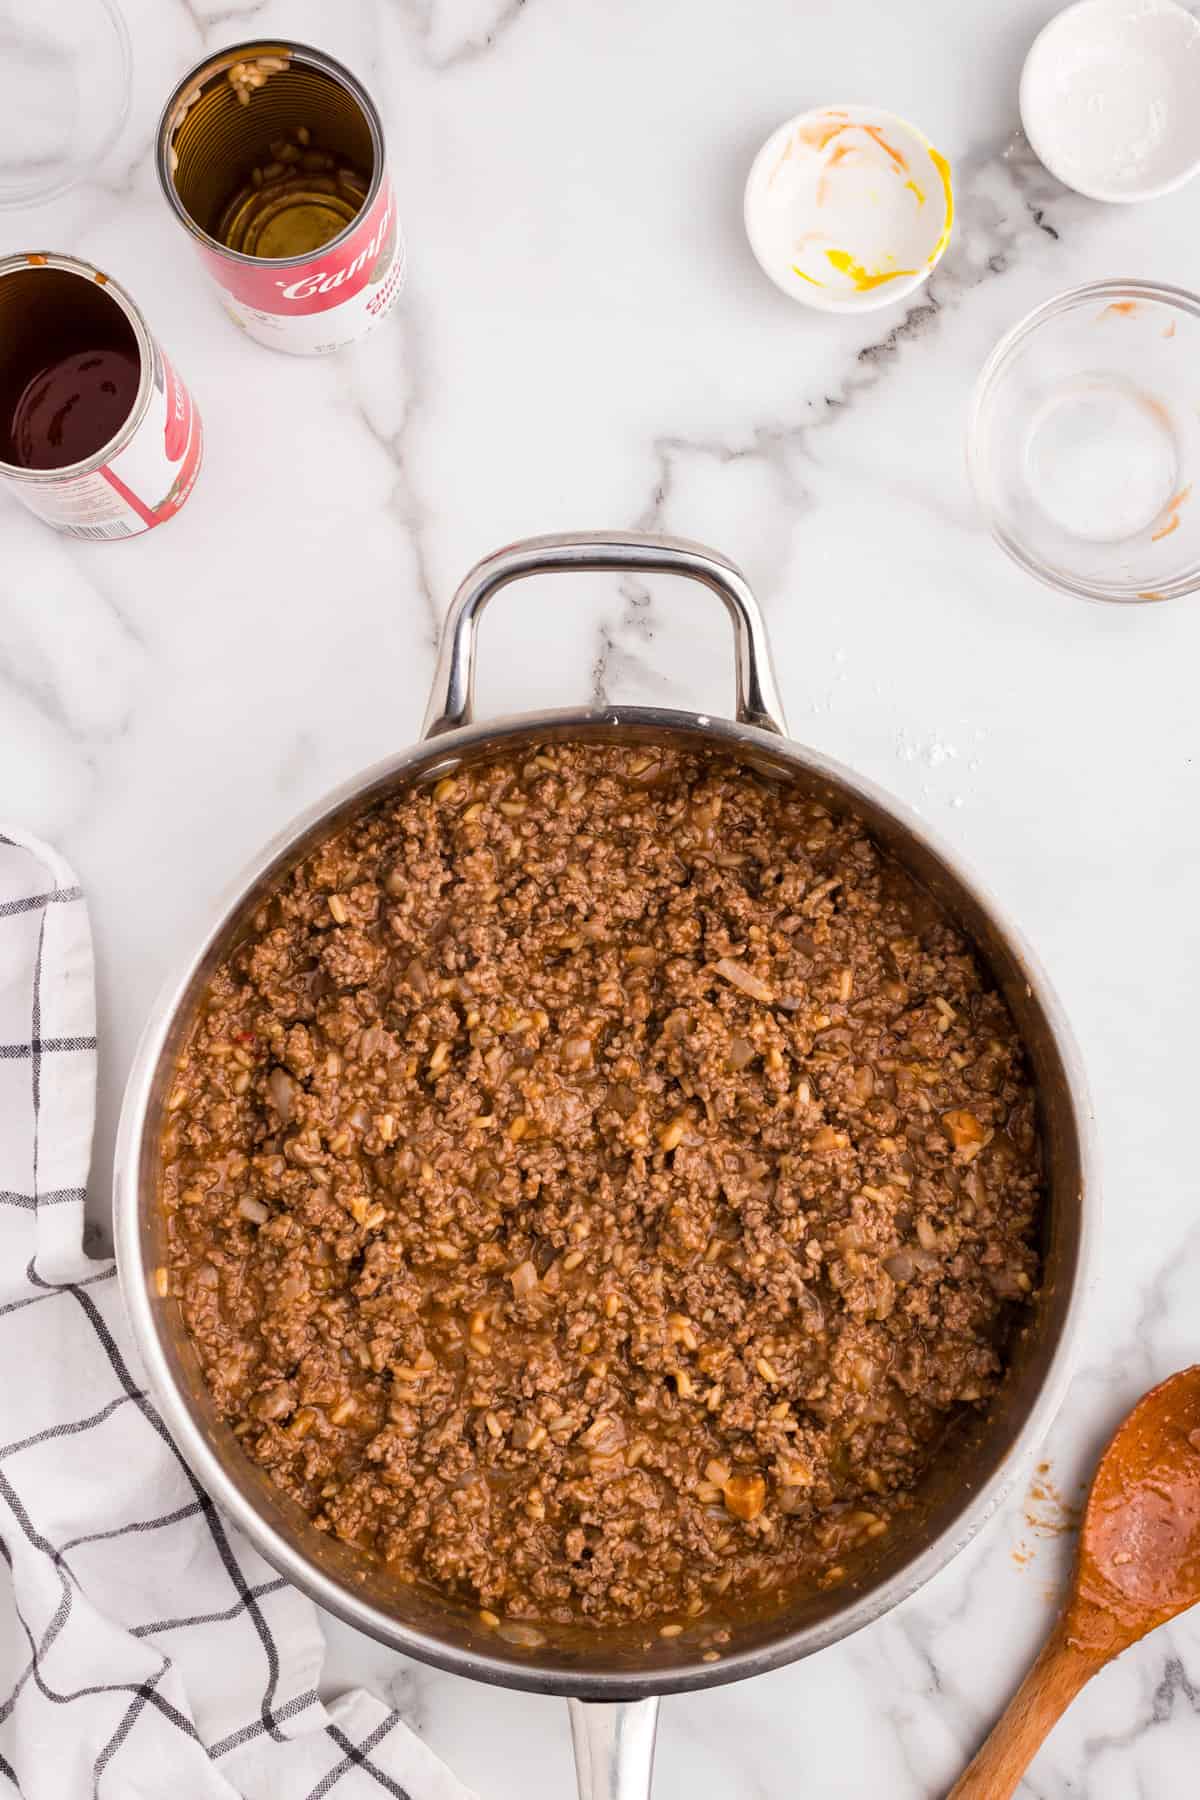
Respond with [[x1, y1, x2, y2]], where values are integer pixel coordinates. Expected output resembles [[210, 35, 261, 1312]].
[[966, 281, 1200, 603]]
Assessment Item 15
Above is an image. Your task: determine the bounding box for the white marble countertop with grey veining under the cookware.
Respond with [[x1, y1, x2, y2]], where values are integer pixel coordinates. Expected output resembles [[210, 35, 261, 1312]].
[[0, 0, 1200, 1800]]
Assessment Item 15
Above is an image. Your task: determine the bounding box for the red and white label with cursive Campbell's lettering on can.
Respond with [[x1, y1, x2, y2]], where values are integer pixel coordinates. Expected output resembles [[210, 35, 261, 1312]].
[[200, 178, 407, 356]]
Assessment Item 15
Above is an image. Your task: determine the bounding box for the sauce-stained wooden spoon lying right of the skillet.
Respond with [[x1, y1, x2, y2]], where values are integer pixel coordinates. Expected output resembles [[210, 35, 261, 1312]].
[[950, 1364, 1200, 1800]]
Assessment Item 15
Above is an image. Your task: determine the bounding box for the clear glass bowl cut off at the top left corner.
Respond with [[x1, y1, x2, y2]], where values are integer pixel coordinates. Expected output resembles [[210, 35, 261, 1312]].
[[0, 0, 133, 207]]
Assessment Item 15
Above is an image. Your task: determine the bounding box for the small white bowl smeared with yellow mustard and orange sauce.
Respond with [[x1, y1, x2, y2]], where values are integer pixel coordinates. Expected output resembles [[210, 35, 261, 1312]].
[[745, 106, 954, 313]]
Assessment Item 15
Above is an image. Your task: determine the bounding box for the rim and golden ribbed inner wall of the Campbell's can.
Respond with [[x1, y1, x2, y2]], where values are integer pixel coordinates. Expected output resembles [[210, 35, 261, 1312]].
[[158, 43, 383, 266]]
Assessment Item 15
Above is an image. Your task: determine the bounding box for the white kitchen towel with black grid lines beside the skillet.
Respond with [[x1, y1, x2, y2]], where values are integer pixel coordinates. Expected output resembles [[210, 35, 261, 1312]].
[[0, 832, 470, 1800]]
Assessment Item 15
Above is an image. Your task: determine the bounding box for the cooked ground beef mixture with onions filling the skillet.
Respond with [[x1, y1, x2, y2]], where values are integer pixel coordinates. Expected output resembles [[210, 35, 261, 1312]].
[[158, 743, 1040, 1642]]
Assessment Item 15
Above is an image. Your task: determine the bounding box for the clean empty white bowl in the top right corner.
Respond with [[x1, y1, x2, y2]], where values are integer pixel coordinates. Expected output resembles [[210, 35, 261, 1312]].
[[1020, 0, 1200, 202]]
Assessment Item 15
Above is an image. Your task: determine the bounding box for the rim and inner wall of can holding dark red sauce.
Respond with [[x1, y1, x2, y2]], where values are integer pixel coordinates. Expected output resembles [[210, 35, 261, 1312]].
[[0, 256, 153, 482]]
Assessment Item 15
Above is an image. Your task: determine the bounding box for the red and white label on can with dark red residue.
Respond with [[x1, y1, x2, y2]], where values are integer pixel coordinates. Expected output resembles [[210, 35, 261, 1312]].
[[0, 344, 203, 540]]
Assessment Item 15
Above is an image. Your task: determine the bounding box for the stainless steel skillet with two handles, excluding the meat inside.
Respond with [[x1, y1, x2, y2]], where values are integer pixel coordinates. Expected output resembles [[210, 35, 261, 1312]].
[[113, 531, 1096, 1800]]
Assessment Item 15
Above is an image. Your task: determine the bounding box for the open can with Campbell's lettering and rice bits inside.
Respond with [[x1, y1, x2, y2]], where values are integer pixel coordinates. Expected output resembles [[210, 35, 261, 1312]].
[[157, 40, 405, 356]]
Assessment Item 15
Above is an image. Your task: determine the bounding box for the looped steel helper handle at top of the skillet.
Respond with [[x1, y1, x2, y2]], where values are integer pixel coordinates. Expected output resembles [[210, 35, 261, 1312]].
[[421, 531, 784, 738]]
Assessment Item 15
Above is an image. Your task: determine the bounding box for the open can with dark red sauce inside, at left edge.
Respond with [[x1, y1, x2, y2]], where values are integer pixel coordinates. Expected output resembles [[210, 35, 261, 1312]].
[[0, 252, 203, 540]]
